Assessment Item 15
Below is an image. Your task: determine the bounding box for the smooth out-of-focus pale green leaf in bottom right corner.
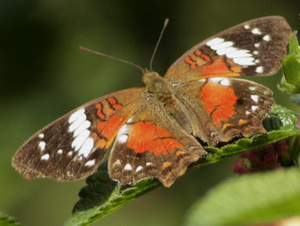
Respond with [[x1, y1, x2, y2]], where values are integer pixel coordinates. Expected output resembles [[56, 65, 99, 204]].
[[186, 168, 300, 226]]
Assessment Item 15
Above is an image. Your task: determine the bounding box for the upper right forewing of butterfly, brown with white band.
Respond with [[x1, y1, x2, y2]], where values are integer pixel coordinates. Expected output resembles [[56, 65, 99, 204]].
[[165, 16, 291, 78]]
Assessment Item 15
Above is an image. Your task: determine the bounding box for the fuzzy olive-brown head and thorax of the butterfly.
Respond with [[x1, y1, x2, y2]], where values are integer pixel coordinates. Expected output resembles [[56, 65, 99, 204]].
[[143, 71, 173, 101]]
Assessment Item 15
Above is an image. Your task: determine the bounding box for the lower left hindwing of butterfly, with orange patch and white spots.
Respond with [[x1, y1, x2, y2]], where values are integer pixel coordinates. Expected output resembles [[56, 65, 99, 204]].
[[108, 102, 207, 187]]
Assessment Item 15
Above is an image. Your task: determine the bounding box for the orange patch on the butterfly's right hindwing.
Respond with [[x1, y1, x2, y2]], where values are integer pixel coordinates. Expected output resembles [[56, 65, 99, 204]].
[[199, 83, 238, 126]]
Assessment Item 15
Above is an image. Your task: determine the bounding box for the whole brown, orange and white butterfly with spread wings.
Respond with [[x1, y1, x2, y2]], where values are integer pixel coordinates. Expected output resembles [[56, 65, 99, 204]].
[[12, 16, 291, 187]]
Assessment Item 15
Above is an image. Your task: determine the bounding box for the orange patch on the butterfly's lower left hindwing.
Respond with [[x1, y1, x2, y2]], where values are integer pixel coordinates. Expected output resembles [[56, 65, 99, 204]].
[[127, 122, 183, 156]]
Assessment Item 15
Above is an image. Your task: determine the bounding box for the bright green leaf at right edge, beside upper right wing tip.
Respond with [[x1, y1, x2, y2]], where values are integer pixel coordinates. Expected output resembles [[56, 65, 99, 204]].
[[278, 34, 300, 93]]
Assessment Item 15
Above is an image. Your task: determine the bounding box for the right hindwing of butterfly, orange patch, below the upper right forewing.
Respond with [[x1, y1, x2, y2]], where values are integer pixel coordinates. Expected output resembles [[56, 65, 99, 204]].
[[169, 77, 275, 146]]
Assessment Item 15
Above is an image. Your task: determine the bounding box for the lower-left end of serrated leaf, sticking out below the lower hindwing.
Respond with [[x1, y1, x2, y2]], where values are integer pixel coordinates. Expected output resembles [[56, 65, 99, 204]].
[[65, 162, 161, 226]]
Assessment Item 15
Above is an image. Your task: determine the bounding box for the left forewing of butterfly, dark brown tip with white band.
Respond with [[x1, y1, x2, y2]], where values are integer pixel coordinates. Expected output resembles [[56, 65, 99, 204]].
[[12, 88, 143, 181]]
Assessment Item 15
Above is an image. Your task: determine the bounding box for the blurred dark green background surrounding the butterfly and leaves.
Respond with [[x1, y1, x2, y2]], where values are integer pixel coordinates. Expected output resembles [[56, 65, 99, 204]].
[[0, 0, 300, 226]]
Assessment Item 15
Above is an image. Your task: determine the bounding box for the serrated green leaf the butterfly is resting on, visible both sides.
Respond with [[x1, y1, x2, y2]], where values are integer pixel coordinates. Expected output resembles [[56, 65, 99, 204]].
[[66, 105, 299, 225]]
